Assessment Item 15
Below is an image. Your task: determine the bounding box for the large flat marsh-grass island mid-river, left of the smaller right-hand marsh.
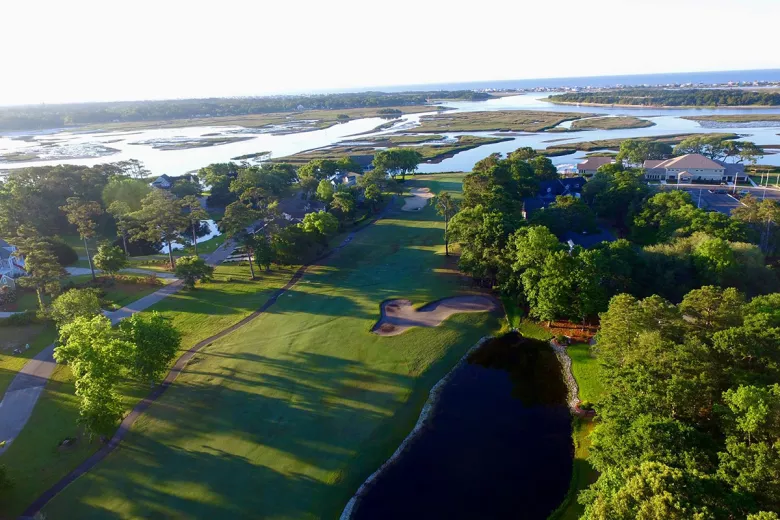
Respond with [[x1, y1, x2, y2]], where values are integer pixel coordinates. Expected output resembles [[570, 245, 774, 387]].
[[414, 110, 593, 132]]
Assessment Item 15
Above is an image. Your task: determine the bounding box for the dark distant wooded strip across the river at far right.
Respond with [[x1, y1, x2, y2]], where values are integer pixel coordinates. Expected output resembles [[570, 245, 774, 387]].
[[549, 88, 780, 106]]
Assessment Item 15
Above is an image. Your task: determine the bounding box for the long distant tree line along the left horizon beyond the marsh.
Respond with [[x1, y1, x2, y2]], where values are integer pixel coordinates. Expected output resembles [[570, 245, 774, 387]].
[[0, 90, 490, 130]]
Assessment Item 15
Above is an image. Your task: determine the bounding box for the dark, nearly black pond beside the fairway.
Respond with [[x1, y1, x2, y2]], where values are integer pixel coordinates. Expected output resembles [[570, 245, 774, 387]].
[[352, 334, 573, 520]]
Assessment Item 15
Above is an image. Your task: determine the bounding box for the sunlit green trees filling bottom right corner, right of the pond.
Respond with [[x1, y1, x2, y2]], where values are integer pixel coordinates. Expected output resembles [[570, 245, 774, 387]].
[[579, 286, 780, 520]]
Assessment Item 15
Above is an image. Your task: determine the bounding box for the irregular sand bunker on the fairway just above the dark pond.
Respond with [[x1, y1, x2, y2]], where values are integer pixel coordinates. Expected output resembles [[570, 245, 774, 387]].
[[371, 295, 499, 336]]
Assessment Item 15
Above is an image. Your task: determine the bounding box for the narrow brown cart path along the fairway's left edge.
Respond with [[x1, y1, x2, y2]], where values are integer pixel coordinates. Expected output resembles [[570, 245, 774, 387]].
[[22, 198, 395, 519]]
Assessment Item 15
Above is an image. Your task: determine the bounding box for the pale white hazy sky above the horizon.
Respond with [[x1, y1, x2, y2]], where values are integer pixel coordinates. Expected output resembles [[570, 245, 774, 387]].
[[6, 0, 780, 105]]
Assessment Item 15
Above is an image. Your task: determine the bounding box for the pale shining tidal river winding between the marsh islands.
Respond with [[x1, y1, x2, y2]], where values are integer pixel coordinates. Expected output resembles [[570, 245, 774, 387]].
[[0, 94, 780, 175]]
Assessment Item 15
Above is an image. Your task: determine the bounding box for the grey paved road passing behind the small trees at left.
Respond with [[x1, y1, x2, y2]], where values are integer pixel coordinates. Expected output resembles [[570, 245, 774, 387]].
[[0, 280, 182, 455]]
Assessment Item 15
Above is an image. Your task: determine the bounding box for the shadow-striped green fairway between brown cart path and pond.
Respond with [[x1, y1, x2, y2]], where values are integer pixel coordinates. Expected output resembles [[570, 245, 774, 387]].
[[45, 179, 498, 519]]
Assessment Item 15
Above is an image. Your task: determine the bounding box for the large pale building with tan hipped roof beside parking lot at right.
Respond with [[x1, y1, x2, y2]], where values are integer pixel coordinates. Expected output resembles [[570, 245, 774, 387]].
[[642, 153, 747, 184]]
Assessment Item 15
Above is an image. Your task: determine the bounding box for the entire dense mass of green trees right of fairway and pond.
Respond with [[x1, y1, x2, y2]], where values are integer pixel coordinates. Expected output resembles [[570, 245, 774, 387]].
[[437, 150, 780, 520]]
